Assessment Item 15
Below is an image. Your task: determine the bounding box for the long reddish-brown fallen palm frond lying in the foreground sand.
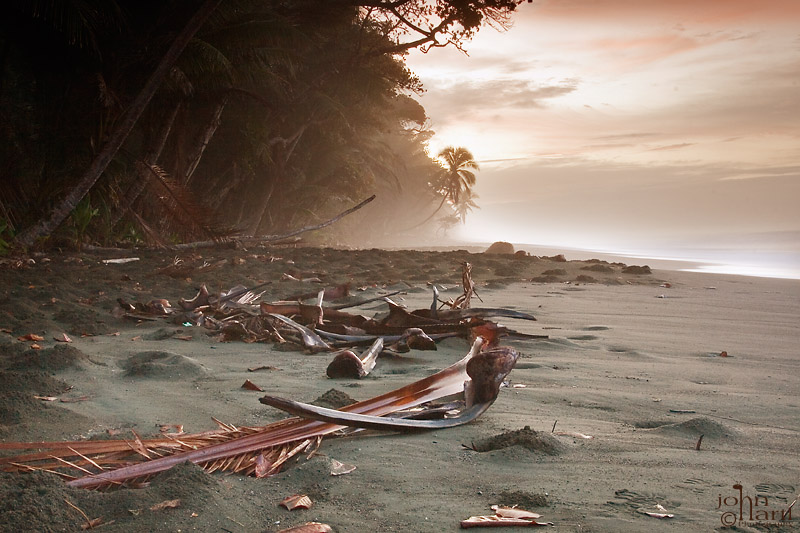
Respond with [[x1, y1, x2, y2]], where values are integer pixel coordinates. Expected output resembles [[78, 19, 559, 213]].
[[0, 337, 516, 488]]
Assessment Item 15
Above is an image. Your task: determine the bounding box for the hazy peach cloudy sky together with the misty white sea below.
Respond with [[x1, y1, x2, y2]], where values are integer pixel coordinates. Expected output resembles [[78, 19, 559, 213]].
[[407, 0, 800, 278]]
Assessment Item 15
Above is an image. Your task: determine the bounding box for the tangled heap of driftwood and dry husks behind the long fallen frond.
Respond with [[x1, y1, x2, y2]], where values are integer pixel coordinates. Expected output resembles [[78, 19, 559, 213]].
[[114, 263, 546, 378]]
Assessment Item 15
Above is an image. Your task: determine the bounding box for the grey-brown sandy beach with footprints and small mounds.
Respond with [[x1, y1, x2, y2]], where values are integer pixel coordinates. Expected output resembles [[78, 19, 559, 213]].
[[0, 247, 800, 532]]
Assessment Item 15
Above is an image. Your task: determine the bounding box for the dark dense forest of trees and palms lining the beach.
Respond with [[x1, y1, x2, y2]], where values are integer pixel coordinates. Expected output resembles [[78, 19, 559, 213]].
[[0, 0, 518, 244]]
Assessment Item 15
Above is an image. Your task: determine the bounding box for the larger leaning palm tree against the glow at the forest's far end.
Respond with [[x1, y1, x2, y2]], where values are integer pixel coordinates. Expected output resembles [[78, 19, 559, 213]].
[[407, 146, 480, 230]]
